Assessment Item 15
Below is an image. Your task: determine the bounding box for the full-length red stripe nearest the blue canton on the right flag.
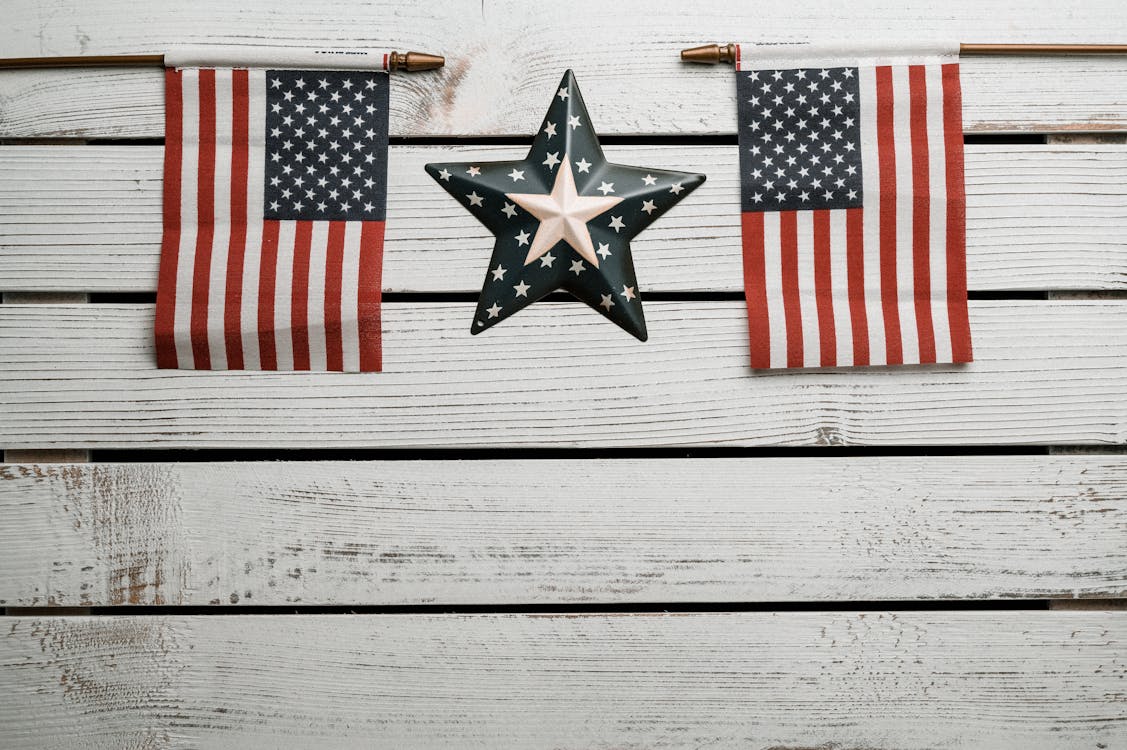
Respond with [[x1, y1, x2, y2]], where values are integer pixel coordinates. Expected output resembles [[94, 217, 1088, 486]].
[[876, 65, 904, 364]]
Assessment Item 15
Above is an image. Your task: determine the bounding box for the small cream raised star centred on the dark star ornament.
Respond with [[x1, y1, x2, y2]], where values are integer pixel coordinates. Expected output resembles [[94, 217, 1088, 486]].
[[505, 159, 622, 268]]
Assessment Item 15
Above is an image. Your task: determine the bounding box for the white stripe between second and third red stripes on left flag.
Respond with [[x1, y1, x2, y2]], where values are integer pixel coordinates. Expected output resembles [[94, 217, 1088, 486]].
[[207, 69, 232, 370]]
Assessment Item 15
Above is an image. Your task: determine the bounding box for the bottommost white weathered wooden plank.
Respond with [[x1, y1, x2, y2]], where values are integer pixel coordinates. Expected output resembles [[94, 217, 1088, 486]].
[[0, 611, 1127, 750]]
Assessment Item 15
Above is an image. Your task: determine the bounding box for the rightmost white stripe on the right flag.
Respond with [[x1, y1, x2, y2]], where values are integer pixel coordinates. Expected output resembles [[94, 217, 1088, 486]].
[[924, 65, 951, 362]]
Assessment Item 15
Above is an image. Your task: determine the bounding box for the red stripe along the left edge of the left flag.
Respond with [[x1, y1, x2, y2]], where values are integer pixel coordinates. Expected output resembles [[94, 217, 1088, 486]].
[[154, 68, 184, 368]]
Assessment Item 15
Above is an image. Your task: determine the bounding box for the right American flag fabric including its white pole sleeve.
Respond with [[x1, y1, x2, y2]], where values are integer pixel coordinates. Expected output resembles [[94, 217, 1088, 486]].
[[736, 45, 971, 368]]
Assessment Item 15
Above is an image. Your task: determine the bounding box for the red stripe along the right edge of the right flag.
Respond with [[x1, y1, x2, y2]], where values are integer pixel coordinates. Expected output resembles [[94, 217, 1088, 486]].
[[943, 63, 973, 362]]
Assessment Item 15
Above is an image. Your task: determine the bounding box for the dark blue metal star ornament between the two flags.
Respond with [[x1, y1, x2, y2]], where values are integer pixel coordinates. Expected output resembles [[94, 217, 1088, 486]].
[[426, 70, 704, 341]]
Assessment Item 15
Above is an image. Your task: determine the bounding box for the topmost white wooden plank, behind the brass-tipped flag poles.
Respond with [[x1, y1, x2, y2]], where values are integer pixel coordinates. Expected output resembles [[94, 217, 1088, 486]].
[[0, 0, 1127, 138]]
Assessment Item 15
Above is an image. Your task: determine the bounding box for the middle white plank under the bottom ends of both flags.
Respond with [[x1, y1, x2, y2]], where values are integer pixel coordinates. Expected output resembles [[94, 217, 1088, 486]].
[[0, 300, 1127, 448]]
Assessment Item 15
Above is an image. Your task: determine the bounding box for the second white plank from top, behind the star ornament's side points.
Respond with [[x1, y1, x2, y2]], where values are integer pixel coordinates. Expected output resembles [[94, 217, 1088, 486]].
[[0, 145, 1127, 292]]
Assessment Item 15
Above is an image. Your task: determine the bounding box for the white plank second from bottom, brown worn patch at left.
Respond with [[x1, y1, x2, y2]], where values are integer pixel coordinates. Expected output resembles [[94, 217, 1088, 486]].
[[0, 456, 1127, 607]]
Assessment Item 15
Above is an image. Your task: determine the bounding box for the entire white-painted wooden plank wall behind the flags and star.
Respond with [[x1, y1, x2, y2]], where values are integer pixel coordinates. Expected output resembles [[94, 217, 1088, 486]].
[[0, 0, 1127, 750]]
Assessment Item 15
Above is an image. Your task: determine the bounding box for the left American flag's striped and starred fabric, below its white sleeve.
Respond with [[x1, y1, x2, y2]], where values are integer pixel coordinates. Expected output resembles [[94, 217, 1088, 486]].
[[156, 68, 389, 372]]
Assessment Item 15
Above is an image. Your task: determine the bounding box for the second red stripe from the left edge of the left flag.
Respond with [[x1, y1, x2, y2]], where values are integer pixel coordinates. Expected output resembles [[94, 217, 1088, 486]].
[[189, 69, 215, 370]]
